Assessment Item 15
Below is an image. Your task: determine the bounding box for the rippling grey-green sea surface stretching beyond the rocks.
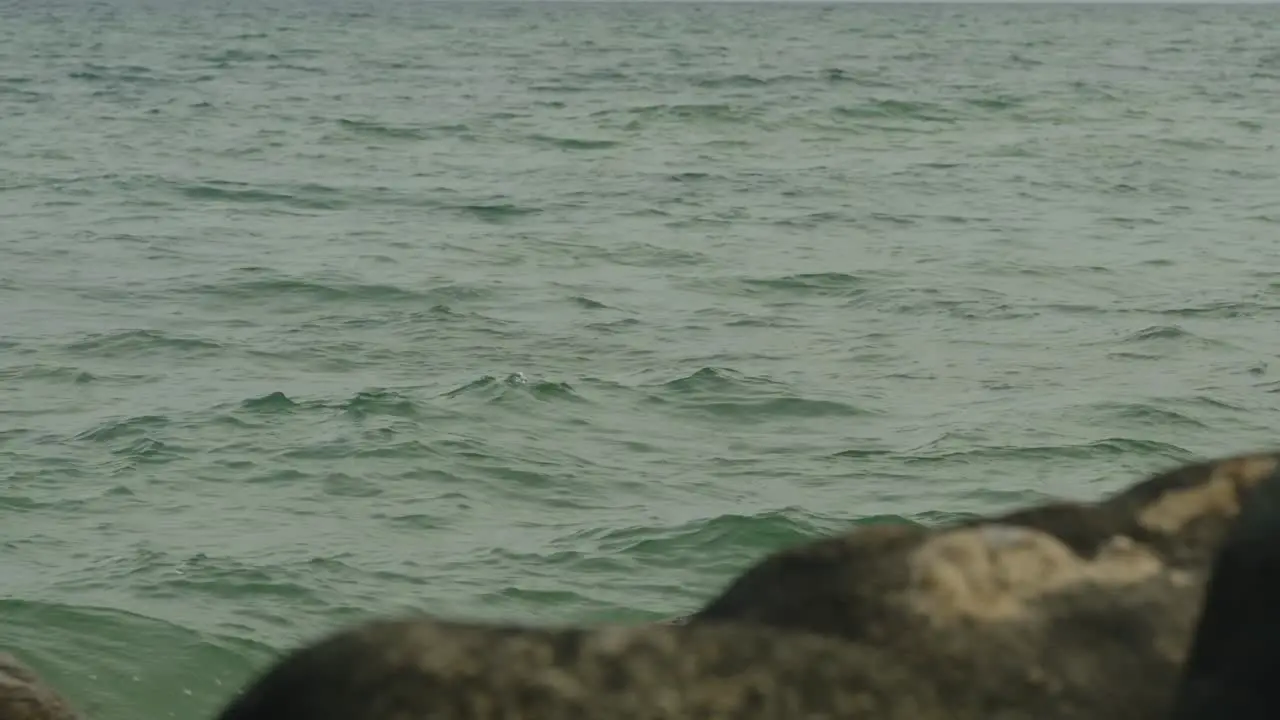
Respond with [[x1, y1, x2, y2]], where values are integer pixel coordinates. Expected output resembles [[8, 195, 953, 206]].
[[0, 0, 1280, 720]]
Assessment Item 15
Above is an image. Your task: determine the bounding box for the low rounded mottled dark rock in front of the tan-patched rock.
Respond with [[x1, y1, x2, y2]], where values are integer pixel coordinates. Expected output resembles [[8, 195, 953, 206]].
[[219, 609, 947, 720]]
